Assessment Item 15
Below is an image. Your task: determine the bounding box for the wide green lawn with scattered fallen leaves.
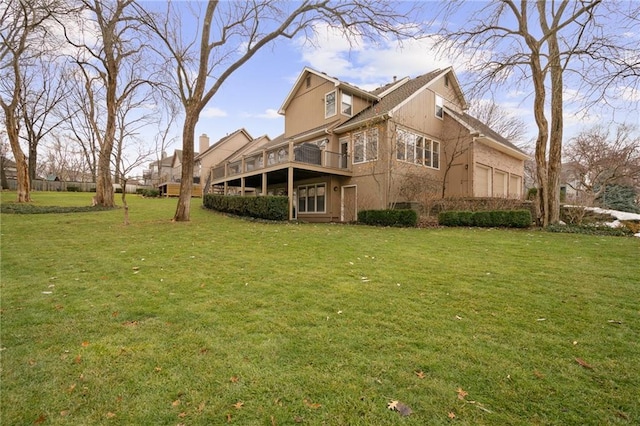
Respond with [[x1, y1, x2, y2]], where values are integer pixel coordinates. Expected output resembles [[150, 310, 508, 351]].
[[0, 193, 640, 425]]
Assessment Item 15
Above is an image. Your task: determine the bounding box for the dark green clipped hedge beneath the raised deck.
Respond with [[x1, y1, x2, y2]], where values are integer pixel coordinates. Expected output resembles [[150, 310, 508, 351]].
[[202, 194, 289, 220]]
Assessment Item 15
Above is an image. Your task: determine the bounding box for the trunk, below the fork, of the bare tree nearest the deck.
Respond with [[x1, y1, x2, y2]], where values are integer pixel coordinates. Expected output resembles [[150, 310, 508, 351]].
[[173, 108, 199, 222]]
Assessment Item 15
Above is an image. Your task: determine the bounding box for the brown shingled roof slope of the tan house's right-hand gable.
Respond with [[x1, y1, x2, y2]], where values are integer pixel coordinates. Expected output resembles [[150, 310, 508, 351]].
[[336, 67, 464, 131]]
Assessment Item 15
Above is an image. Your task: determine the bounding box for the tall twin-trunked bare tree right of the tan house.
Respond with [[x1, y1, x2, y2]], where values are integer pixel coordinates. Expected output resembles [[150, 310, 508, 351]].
[[432, 0, 637, 226]]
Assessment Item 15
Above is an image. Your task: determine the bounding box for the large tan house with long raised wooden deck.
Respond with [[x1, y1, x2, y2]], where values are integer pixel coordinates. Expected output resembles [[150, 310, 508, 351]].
[[210, 68, 527, 222]]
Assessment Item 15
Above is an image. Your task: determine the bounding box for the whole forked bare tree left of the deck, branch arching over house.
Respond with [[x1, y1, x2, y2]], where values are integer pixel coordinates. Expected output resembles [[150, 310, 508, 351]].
[[140, 0, 422, 221]]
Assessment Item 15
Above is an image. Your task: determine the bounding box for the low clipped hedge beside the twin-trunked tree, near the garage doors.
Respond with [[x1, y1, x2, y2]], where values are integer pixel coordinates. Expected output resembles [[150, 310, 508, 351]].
[[438, 210, 532, 228]]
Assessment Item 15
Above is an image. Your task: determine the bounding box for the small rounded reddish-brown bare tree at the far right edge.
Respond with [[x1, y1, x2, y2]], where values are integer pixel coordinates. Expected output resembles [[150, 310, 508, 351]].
[[565, 125, 640, 200]]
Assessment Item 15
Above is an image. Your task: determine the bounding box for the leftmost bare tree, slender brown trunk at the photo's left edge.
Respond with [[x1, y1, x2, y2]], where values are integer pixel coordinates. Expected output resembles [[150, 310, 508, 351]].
[[0, 0, 56, 203]]
